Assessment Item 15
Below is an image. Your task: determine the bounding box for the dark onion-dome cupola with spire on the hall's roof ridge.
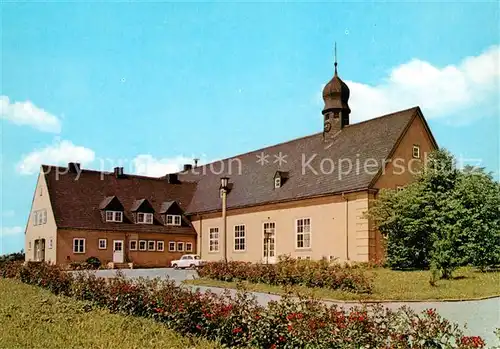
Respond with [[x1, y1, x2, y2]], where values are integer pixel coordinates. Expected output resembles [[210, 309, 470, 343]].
[[322, 47, 351, 138]]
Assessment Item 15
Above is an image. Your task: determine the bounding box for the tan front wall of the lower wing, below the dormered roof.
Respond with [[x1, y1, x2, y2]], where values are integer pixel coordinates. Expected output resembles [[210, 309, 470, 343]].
[[57, 229, 196, 267]]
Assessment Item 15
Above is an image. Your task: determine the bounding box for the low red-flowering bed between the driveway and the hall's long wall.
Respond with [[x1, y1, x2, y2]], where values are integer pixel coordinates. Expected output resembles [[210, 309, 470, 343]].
[[198, 258, 372, 293]]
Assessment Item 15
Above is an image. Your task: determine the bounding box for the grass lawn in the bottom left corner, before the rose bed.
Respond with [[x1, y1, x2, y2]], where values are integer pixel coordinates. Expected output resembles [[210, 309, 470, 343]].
[[0, 279, 221, 349]]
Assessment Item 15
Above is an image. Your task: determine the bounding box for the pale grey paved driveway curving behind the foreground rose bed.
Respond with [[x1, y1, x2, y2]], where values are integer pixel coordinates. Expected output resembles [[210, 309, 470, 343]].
[[92, 268, 500, 347]]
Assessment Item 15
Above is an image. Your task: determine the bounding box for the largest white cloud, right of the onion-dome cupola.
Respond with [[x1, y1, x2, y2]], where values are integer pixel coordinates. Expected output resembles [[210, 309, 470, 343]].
[[321, 46, 500, 122]]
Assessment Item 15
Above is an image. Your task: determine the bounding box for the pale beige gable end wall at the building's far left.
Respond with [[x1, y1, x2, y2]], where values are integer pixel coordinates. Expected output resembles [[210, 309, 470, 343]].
[[24, 171, 57, 263]]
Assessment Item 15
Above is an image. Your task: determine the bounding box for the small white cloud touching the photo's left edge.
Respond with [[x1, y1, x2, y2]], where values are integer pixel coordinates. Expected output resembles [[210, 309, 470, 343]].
[[0, 96, 61, 133]]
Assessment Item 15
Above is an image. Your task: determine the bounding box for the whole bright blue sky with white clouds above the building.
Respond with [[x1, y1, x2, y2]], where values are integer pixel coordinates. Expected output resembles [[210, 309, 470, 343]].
[[0, 2, 500, 254]]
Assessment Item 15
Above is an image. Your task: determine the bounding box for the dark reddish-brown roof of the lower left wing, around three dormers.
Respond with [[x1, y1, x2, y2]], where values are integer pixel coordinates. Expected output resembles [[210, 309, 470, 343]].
[[42, 165, 196, 234]]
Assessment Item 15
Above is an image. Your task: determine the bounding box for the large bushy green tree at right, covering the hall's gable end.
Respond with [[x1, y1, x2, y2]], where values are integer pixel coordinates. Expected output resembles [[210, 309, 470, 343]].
[[368, 150, 500, 278]]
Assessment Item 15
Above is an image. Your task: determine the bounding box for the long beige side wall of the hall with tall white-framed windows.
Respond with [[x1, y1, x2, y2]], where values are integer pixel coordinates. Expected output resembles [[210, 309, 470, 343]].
[[193, 192, 369, 262]]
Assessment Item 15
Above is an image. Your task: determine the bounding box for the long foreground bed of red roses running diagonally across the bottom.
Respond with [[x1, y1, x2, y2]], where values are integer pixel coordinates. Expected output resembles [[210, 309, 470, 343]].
[[0, 263, 485, 349]]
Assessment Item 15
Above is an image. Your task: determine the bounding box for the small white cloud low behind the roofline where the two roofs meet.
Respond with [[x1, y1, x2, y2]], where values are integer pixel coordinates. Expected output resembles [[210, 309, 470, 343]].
[[132, 154, 206, 177]]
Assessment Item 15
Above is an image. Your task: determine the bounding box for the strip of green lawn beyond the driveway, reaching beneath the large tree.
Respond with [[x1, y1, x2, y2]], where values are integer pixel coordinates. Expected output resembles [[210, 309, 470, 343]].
[[186, 268, 500, 300]]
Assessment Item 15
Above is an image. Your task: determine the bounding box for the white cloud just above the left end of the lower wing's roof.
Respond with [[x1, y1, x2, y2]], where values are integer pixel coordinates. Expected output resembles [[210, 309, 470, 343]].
[[17, 140, 95, 175]]
